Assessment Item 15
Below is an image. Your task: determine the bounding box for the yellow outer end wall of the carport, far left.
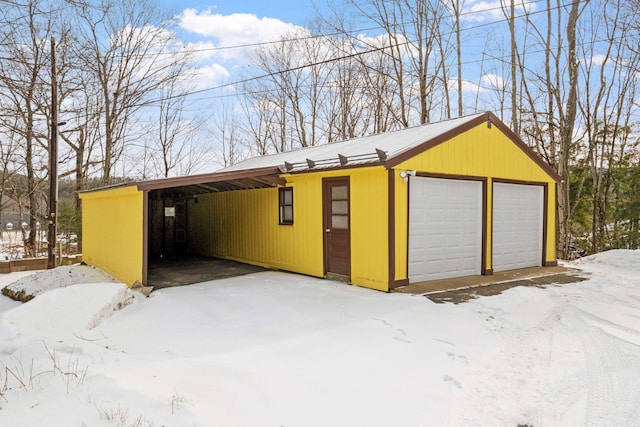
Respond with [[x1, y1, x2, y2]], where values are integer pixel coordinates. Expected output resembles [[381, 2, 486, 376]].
[[80, 187, 144, 285]]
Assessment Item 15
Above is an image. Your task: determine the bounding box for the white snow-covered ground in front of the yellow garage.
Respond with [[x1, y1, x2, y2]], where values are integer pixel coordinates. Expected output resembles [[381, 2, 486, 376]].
[[0, 251, 640, 427]]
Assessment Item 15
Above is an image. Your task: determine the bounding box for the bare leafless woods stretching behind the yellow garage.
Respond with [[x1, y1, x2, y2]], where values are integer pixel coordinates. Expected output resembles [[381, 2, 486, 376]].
[[0, 0, 640, 258]]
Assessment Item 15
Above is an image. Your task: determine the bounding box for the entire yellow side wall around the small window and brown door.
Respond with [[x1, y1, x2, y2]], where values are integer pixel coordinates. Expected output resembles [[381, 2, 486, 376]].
[[188, 167, 388, 291]]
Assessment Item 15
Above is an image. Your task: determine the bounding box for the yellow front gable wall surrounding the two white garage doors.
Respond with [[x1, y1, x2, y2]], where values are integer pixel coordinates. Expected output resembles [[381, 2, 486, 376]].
[[395, 124, 556, 280]]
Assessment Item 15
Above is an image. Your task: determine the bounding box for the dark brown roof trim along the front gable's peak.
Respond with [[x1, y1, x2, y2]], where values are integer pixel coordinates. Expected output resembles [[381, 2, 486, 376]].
[[385, 111, 562, 182]]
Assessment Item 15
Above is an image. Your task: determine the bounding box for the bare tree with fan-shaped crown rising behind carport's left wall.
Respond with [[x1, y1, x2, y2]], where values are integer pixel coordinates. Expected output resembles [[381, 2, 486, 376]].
[[70, 0, 188, 183]]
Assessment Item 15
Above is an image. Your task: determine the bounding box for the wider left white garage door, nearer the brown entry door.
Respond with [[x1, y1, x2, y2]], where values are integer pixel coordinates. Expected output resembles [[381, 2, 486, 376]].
[[409, 177, 482, 283]]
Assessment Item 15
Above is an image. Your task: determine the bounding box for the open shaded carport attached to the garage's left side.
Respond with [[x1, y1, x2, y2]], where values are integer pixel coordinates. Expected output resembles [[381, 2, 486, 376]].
[[81, 167, 285, 286]]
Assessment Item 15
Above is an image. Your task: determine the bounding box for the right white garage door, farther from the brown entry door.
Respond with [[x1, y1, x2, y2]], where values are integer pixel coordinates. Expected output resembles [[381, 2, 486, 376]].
[[493, 183, 544, 271]]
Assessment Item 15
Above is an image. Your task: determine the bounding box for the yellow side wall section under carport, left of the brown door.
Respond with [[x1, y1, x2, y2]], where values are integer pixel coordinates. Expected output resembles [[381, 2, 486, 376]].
[[189, 179, 323, 276]]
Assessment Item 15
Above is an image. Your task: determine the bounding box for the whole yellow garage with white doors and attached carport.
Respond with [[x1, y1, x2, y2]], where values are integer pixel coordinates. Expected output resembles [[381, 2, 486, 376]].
[[81, 113, 559, 291]]
